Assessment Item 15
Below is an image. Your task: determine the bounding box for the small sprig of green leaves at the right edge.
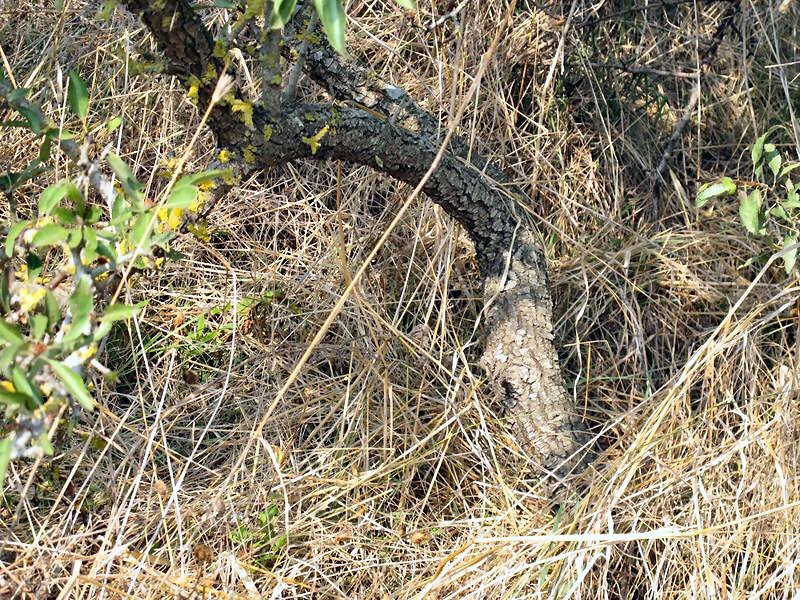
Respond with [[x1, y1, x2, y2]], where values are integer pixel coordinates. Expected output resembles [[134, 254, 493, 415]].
[[695, 127, 800, 274]]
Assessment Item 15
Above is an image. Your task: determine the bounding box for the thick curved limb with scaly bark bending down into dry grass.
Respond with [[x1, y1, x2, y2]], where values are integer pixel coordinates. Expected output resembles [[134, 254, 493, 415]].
[[255, 105, 586, 471]]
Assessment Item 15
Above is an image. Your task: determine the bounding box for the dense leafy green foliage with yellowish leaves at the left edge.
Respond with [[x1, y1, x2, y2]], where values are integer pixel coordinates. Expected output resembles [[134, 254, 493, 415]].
[[0, 72, 227, 483]]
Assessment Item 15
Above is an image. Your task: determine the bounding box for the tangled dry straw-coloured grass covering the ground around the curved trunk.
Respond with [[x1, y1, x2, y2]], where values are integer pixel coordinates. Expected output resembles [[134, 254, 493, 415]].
[[0, 0, 800, 599]]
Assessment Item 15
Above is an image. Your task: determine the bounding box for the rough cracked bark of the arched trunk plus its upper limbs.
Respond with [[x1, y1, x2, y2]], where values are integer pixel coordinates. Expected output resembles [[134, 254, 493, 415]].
[[125, 0, 586, 475]]
